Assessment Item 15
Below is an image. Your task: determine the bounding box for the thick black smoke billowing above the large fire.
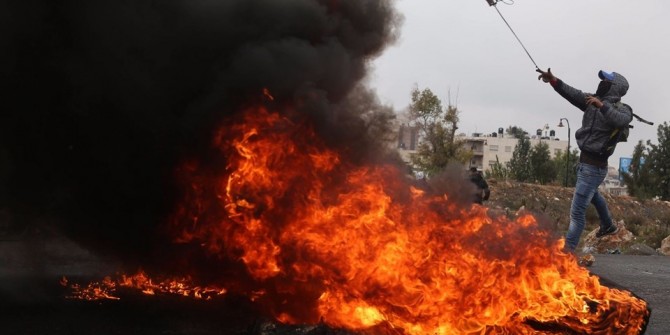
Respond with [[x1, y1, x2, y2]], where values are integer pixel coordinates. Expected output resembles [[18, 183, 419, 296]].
[[0, 0, 399, 262]]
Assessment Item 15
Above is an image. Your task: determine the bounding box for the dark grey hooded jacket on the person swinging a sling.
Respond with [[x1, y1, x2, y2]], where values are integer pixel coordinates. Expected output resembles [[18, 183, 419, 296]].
[[553, 71, 633, 163]]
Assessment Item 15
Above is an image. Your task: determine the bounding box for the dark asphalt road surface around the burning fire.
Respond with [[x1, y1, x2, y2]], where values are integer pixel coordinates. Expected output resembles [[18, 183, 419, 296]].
[[0, 239, 670, 335]]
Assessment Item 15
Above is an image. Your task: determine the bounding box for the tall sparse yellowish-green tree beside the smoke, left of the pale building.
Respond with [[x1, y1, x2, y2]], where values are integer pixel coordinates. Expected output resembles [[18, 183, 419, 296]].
[[409, 87, 471, 176]]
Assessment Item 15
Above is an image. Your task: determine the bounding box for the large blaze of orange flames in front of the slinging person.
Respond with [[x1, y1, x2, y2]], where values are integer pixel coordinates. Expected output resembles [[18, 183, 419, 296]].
[[171, 107, 648, 334]]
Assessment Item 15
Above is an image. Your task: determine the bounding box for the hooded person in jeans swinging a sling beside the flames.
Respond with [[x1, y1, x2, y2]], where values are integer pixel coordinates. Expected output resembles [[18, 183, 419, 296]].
[[537, 69, 633, 252]]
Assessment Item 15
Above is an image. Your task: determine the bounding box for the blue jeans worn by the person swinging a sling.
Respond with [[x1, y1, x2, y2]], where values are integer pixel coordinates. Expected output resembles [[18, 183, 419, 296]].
[[565, 163, 612, 251]]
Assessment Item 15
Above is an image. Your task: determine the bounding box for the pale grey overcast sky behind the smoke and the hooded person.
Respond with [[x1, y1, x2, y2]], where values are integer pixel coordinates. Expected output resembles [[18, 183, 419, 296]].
[[370, 0, 670, 167]]
